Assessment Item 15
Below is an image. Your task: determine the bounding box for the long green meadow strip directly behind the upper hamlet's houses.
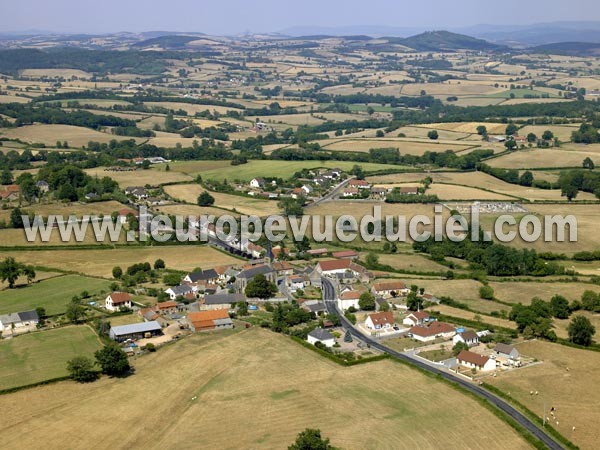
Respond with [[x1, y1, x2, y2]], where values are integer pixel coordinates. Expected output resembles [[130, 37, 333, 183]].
[[170, 161, 403, 181]]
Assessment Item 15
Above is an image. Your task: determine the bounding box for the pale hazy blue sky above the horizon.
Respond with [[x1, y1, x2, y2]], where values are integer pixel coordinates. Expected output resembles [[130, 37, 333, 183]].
[[0, 0, 600, 35]]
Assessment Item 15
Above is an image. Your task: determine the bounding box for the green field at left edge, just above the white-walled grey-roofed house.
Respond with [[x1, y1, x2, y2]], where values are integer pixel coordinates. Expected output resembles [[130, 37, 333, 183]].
[[0, 275, 110, 315]]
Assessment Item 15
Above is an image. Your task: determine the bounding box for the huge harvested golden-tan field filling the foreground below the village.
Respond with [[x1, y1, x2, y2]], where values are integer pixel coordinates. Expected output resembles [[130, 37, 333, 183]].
[[0, 329, 529, 449]]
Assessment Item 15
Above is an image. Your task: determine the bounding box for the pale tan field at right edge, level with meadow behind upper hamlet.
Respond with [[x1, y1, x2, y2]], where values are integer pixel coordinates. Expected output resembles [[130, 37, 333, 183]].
[[487, 149, 600, 169]]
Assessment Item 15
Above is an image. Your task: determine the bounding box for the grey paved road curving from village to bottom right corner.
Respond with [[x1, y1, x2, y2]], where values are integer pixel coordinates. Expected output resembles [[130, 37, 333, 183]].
[[322, 278, 563, 450]]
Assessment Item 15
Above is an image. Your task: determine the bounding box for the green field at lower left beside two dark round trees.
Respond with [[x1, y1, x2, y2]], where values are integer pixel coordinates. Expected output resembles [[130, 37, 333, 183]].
[[0, 325, 100, 389]]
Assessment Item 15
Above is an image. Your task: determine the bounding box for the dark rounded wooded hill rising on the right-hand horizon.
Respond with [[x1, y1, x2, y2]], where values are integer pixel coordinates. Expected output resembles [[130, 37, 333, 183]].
[[390, 31, 506, 51]]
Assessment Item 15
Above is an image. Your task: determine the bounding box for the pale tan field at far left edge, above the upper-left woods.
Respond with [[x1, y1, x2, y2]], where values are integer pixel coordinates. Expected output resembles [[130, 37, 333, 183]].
[[0, 125, 140, 147]]
